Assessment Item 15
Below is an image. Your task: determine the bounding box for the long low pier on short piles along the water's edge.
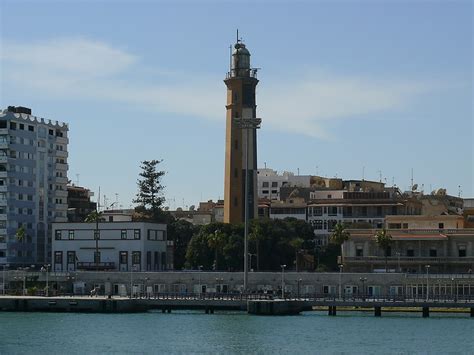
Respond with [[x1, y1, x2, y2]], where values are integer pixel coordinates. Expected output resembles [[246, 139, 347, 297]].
[[0, 294, 474, 318]]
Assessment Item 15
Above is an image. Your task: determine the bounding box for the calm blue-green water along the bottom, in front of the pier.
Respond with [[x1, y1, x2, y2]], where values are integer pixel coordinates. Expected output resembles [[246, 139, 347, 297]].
[[0, 312, 474, 354]]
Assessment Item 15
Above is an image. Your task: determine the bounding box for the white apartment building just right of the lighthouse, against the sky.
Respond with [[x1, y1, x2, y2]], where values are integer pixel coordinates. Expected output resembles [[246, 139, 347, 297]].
[[257, 168, 311, 200]]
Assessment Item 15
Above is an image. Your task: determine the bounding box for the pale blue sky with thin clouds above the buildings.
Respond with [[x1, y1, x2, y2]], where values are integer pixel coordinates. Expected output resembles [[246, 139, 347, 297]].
[[0, 0, 474, 209]]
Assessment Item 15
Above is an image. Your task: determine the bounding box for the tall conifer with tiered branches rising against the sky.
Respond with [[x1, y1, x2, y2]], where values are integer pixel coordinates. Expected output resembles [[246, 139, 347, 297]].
[[133, 160, 165, 222]]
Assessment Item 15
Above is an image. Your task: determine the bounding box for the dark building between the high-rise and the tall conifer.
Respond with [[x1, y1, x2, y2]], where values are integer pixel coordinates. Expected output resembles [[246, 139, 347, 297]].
[[67, 185, 96, 222]]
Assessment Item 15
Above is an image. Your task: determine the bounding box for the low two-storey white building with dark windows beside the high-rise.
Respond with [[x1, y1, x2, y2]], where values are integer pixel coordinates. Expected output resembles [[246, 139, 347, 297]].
[[52, 222, 173, 271]]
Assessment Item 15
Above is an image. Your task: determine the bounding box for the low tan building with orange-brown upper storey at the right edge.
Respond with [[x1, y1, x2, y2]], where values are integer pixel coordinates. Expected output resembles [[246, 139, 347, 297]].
[[343, 215, 474, 273]]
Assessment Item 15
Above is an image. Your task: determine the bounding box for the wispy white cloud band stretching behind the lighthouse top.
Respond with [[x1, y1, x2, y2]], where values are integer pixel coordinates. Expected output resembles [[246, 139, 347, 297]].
[[1, 38, 428, 139]]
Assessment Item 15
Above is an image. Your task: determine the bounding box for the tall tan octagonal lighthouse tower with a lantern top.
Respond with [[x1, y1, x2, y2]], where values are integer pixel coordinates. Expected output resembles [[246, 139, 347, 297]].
[[224, 35, 261, 223]]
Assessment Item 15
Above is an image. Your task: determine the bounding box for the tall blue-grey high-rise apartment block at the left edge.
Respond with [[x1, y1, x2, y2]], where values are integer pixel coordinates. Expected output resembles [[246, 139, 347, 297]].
[[0, 106, 68, 267]]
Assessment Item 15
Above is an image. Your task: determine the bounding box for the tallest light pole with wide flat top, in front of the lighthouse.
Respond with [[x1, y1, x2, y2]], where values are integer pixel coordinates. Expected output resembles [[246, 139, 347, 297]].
[[233, 117, 262, 292]]
